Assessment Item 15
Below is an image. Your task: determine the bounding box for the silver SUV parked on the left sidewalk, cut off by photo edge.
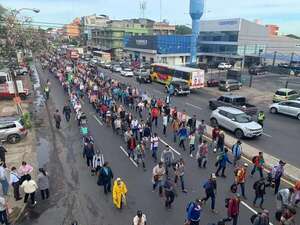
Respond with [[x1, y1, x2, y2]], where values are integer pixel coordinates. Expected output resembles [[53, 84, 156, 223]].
[[0, 117, 27, 144]]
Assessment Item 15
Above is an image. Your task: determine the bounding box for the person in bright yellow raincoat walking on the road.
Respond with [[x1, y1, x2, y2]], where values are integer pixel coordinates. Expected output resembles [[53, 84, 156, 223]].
[[112, 178, 127, 209]]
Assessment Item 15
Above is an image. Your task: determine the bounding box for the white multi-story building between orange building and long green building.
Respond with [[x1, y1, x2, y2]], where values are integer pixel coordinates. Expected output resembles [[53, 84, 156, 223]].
[[81, 14, 109, 45]]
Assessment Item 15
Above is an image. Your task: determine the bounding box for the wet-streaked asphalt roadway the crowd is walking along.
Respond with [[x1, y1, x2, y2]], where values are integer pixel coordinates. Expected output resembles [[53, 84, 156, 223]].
[[20, 61, 300, 225]]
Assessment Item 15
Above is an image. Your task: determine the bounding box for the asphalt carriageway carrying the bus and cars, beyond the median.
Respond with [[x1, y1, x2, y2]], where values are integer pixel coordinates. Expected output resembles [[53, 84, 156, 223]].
[[99, 68, 300, 167]]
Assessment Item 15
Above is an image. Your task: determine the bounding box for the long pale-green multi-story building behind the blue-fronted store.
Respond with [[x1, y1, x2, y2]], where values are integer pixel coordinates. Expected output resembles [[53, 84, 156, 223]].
[[92, 19, 175, 59]]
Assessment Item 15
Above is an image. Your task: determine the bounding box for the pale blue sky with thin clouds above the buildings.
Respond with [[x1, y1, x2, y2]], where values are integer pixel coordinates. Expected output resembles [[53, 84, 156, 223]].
[[0, 0, 300, 35]]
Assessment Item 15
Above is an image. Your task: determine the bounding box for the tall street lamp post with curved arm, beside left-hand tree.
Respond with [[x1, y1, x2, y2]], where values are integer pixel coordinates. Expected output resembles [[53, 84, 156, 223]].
[[7, 8, 40, 114]]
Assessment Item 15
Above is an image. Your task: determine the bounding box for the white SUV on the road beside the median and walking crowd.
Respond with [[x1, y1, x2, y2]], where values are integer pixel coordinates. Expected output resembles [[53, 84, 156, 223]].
[[210, 106, 263, 139]]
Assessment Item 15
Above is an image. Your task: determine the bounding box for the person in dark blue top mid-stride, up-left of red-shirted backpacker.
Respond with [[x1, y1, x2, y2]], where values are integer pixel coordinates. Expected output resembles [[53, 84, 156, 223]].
[[201, 173, 217, 213]]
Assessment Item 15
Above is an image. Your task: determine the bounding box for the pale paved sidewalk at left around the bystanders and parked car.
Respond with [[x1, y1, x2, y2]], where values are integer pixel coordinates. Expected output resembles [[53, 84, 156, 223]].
[[0, 100, 37, 224]]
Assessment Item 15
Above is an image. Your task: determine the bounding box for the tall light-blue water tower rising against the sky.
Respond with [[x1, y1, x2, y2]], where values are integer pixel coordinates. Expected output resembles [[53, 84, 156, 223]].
[[190, 0, 204, 64]]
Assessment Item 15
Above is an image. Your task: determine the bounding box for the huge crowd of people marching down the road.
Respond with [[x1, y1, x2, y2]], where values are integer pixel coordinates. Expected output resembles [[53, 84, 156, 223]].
[[37, 50, 300, 225]]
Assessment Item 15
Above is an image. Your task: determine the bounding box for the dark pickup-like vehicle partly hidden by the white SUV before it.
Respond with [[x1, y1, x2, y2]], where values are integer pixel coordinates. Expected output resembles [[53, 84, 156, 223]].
[[209, 95, 257, 115]]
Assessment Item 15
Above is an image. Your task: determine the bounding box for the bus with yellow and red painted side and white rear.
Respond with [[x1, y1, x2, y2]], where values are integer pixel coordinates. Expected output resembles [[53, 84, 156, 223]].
[[150, 63, 204, 89]]
